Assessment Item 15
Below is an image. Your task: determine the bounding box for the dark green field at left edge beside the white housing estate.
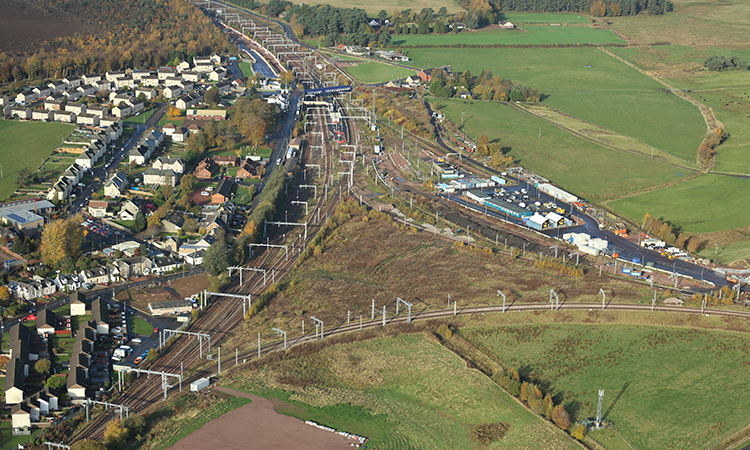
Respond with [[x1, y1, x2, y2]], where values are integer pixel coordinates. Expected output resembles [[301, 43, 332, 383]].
[[0, 120, 75, 199]]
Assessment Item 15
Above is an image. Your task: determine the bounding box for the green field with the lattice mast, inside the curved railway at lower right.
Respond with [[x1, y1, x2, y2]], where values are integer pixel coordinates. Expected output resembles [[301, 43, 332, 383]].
[[461, 324, 750, 449]]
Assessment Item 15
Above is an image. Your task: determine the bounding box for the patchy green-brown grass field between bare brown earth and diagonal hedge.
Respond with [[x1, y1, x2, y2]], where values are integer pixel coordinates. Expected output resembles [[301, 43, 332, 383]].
[[224, 335, 577, 449]]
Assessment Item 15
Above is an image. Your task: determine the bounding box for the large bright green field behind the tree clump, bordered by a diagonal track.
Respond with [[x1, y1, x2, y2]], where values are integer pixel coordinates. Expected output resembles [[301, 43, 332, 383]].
[[408, 48, 706, 161]]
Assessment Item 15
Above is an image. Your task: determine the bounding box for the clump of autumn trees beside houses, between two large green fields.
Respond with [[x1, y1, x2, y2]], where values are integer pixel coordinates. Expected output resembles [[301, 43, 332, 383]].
[[430, 69, 542, 102]]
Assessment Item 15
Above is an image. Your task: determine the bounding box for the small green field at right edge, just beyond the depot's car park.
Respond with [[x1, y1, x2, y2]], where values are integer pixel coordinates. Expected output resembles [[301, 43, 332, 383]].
[[608, 174, 750, 234]]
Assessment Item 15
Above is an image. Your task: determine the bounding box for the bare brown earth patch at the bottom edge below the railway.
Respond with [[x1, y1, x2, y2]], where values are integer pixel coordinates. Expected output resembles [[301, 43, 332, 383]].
[[167, 387, 356, 450]]
